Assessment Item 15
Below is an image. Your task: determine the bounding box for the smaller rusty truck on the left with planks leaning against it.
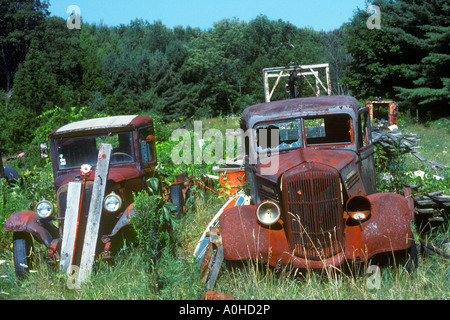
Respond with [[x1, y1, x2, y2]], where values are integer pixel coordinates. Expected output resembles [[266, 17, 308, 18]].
[[4, 115, 183, 277]]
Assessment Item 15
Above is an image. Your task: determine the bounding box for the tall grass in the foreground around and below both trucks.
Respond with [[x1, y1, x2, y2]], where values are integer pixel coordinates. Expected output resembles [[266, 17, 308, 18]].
[[0, 180, 450, 300]]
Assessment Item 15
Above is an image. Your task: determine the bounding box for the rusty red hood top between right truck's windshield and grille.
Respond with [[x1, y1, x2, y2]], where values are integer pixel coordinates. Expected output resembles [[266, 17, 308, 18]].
[[256, 148, 357, 183]]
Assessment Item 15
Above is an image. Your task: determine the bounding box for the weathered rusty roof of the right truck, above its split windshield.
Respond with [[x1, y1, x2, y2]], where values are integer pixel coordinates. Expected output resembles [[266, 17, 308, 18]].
[[241, 96, 360, 129]]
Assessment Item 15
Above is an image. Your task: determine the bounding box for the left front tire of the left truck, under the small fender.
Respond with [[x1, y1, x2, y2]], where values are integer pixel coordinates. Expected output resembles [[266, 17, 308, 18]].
[[13, 232, 33, 279]]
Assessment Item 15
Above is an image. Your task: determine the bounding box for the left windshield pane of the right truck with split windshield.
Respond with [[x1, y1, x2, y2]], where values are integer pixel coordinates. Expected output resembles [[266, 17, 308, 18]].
[[256, 120, 302, 151]]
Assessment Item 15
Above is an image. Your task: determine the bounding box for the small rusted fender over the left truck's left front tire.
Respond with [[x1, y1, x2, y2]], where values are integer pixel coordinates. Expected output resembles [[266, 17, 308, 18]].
[[3, 211, 53, 248]]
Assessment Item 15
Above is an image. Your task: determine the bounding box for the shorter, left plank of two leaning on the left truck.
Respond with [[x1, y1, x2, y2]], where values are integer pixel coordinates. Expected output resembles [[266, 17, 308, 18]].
[[59, 182, 82, 275]]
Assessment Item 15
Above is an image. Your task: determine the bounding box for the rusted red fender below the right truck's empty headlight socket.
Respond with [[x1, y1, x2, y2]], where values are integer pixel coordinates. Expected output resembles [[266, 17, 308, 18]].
[[344, 193, 413, 261]]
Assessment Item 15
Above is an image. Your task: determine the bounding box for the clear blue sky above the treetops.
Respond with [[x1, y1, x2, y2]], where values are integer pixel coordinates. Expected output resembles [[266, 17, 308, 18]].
[[50, 0, 365, 31]]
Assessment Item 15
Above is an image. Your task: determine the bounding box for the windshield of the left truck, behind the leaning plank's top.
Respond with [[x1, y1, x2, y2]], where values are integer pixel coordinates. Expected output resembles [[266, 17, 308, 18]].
[[56, 132, 134, 169]]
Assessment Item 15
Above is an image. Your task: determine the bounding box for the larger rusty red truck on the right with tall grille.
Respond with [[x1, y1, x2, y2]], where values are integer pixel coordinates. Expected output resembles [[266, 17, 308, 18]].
[[197, 96, 416, 288]]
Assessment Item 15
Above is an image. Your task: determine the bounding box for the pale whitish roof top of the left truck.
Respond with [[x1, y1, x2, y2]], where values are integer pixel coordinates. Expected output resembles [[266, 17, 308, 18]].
[[50, 115, 152, 135]]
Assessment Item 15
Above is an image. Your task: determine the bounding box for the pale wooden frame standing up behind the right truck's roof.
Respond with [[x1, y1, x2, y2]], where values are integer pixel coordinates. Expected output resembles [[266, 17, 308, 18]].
[[263, 63, 331, 102]]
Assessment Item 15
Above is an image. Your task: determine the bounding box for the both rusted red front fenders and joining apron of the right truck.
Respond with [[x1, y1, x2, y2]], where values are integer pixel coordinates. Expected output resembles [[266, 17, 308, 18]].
[[220, 193, 412, 268]]
